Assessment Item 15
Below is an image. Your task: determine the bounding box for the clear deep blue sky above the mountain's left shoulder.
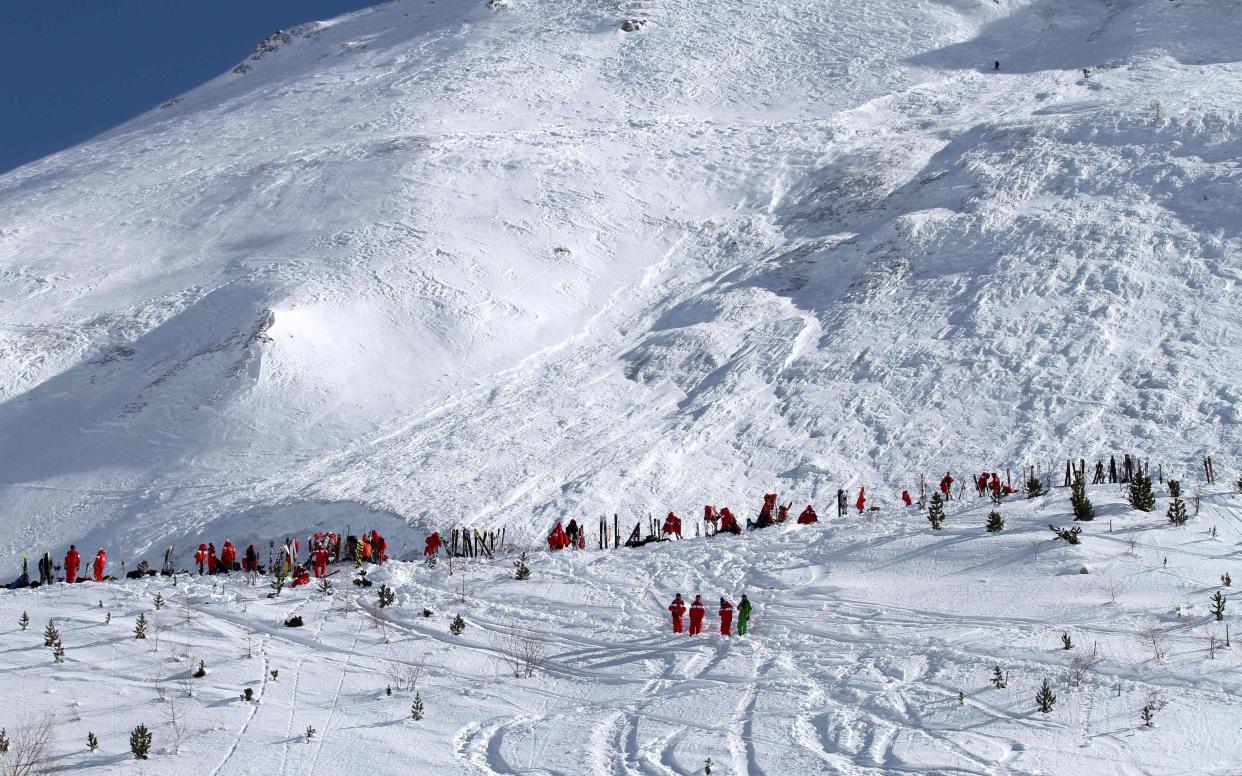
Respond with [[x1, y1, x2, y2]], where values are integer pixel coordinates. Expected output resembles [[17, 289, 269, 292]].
[[0, 0, 379, 173]]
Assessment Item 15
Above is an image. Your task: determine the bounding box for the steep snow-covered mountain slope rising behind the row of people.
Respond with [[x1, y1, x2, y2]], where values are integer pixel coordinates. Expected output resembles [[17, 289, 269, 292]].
[[0, 0, 1242, 557]]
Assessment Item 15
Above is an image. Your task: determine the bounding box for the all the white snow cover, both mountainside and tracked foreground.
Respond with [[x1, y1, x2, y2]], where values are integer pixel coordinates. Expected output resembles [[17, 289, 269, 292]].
[[0, 0, 1242, 776]]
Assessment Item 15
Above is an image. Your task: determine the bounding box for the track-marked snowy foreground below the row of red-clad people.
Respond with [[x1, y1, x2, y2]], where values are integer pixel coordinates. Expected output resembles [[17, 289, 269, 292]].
[[0, 484, 1242, 776]]
